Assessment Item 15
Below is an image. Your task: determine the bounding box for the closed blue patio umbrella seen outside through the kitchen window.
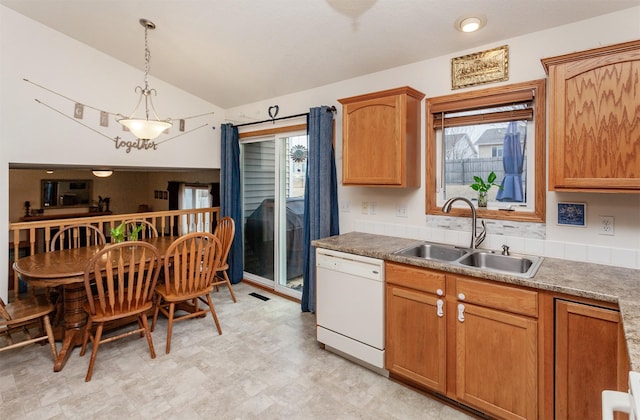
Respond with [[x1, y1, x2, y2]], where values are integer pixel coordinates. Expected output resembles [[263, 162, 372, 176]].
[[496, 121, 524, 202]]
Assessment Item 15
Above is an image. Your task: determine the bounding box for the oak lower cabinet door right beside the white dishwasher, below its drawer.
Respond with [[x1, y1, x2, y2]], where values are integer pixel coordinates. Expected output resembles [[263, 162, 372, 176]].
[[385, 285, 446, 393]]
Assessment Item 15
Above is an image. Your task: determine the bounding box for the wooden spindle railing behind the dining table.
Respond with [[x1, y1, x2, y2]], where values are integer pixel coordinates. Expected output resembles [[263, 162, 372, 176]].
[[9, 207, 220, 296]]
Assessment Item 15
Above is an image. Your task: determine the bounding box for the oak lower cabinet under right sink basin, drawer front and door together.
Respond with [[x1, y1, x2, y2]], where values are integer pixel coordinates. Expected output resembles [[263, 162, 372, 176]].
[[456, 275, 539, 419]]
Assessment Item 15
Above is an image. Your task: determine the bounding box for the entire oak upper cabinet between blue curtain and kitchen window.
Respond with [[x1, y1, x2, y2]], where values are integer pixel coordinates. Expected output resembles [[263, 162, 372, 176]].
[[338, 87, 424, 187]]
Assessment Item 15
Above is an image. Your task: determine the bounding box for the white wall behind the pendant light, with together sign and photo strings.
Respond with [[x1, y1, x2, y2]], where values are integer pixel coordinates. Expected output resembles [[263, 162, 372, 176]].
[[0, 6, 224, 299]]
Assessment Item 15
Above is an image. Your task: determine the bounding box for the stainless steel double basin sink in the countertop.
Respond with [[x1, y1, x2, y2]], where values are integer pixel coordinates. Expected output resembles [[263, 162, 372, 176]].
[[394, 242, 542, 278]]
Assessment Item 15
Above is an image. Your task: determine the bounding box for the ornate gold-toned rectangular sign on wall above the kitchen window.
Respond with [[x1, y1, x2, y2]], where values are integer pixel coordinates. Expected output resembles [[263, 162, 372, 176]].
[[451, 45, 509, 89]]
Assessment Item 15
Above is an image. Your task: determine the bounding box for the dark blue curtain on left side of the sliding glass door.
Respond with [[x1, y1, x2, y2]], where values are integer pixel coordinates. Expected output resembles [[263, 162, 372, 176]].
[[220, 124, 243, 284]]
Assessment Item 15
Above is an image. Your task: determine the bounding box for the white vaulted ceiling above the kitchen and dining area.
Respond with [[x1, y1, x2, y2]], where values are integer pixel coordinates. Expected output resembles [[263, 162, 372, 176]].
[[0, 0, 640, 108]]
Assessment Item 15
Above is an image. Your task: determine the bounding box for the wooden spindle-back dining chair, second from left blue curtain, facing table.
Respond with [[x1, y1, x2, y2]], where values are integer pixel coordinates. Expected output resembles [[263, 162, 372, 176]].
[[151, 232, 222, 354]]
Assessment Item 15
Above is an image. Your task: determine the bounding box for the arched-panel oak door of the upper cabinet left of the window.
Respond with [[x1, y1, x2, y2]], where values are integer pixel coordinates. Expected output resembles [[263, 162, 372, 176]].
[[342, 95, 405, 185]]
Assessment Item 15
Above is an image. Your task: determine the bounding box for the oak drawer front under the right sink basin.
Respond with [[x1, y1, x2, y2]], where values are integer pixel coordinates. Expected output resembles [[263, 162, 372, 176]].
[[456, 277, 538, 318]]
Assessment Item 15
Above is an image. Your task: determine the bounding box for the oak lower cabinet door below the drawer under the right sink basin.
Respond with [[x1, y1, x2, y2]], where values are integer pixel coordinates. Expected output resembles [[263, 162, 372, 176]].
[[456, 302, 538, 419]]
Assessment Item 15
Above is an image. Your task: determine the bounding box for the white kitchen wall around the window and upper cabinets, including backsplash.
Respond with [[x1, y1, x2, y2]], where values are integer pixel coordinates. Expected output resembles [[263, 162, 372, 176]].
[[227, 7, 640, 268]]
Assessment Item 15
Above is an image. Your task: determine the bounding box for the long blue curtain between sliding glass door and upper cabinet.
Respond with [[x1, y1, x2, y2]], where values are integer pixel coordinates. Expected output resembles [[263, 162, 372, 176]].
[[301, 106, 339, 312]]
